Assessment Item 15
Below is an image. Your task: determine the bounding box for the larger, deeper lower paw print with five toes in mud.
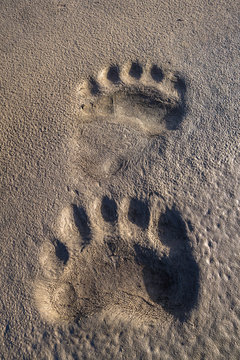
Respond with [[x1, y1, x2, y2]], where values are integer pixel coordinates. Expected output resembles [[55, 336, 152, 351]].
[[35, 196, 199, 323]]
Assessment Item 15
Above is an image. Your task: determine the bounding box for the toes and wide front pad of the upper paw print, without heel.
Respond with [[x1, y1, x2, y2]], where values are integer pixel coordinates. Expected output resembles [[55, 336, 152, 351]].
[[76, 62, 185, 136]]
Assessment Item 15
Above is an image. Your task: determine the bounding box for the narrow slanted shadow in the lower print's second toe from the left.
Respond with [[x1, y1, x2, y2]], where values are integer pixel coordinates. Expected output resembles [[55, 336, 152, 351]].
[[72, 204, 91, 248]]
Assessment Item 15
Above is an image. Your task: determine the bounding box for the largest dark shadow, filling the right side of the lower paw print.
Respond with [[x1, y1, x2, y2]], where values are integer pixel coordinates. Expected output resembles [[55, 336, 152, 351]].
[[134, 208, 199, 322]]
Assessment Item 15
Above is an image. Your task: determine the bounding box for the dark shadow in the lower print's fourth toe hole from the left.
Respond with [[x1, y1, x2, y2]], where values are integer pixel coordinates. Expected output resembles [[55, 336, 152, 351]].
[[128, 199, 150, 229]]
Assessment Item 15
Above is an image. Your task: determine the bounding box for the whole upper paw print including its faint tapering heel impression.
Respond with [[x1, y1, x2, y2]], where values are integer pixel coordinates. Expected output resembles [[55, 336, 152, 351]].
[[72, 61, 186, 181]]
